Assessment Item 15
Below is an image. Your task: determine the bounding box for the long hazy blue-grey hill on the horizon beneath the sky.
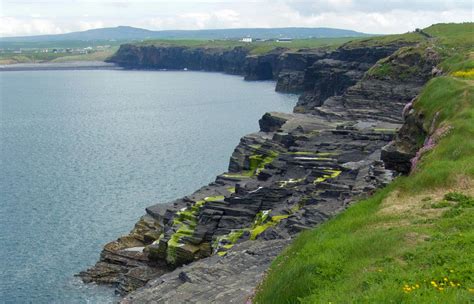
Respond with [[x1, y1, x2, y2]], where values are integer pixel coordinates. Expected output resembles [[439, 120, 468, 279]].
[[0, 26, 368, 43]]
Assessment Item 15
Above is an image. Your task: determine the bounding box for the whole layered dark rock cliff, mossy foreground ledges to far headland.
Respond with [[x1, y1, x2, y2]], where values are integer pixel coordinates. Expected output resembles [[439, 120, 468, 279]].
[[80, 33, 437, 303]]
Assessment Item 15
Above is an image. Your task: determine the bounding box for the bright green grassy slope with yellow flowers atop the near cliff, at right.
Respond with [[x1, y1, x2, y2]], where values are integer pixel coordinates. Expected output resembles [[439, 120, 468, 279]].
[[255, 23, 474, 303]]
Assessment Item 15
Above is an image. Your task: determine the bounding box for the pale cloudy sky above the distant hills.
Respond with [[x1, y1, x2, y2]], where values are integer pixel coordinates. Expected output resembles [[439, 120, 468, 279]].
[[0, 0, 474, 37]]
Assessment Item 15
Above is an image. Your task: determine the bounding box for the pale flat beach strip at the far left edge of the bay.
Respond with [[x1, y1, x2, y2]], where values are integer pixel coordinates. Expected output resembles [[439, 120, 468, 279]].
[[0, 61, 123, 72]]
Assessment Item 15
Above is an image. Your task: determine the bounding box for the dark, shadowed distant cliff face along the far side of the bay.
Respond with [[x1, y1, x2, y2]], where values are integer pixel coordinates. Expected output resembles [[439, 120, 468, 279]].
[[109, 44, 408, 101]]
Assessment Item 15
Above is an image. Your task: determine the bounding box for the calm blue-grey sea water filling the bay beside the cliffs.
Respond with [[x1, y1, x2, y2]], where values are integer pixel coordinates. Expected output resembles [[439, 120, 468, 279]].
[[0, 70, 296, 303]]
